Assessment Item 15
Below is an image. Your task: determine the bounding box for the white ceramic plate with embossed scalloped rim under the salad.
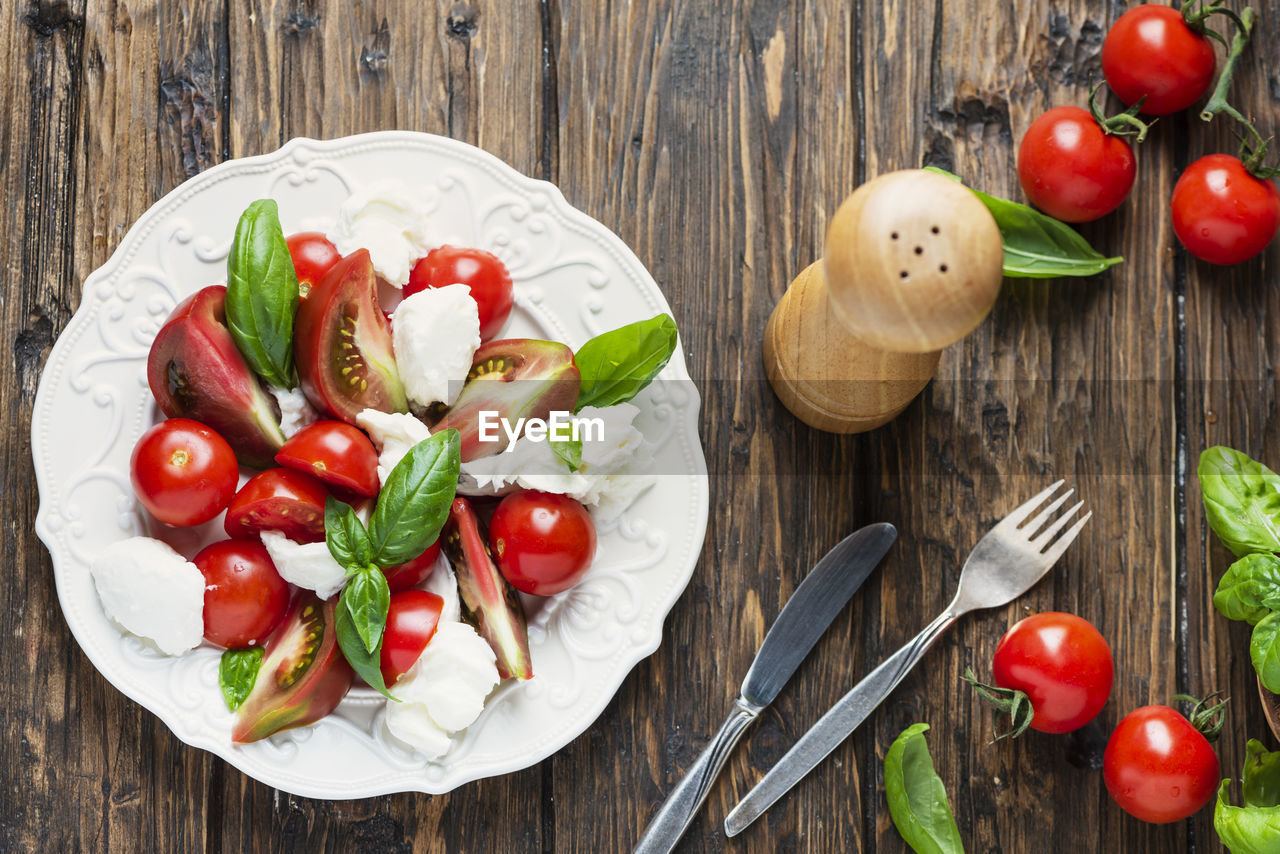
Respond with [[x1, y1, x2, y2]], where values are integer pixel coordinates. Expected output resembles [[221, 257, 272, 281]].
[[32, 132, 708, 799]]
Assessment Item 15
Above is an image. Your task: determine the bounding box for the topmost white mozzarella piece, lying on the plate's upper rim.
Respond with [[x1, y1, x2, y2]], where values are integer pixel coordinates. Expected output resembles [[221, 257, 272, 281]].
[[328, 182, 439, 288]]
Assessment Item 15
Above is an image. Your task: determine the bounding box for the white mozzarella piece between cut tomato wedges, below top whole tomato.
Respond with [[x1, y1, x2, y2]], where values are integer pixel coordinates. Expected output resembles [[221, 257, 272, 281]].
[[392, 284, 480, 406]]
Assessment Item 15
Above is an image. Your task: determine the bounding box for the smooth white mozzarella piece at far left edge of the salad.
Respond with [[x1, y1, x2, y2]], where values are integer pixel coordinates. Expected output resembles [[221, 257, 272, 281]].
[[90, 536, 205, 656]]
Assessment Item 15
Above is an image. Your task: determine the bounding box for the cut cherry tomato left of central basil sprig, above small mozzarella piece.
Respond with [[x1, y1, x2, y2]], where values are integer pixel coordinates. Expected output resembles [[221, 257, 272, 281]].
[[224, 469, 329, 543]]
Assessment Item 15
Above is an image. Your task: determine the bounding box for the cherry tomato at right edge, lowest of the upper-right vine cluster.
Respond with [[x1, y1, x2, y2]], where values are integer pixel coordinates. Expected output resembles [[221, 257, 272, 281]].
[[1171, 154, 1280, 264]]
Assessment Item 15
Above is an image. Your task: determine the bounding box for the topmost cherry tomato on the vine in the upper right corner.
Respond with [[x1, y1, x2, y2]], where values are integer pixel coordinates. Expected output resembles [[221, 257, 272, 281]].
[[1102, 4, 1215, 115]]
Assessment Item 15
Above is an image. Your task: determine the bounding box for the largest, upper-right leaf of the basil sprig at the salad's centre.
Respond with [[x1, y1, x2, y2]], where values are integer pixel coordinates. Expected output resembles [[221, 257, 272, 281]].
[[369, 429, 462, 567]]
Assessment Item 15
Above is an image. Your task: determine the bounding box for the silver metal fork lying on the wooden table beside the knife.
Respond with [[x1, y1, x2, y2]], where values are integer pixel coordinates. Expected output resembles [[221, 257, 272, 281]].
[[724, 480, 1093, 836]]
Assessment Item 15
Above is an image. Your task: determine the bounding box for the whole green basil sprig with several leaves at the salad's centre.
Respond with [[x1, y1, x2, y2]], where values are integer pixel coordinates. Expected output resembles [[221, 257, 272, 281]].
[[324, 430, 461, 699]]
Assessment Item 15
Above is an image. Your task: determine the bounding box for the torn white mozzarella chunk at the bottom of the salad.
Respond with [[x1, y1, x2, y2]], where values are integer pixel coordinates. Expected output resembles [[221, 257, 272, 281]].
[[387, 622, 499, 759]]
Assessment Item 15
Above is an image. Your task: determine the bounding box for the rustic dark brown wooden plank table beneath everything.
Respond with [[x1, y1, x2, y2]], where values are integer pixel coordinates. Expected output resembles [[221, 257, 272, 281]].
[[10, 0, 1280, 854]]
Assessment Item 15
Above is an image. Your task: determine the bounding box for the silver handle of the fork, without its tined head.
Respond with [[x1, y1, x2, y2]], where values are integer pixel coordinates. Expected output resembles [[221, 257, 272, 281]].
[[724, 608, 960, 836]]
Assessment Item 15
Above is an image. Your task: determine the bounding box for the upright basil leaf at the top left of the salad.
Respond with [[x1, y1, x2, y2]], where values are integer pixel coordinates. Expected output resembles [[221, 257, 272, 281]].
[[227, 198, 298, 388]]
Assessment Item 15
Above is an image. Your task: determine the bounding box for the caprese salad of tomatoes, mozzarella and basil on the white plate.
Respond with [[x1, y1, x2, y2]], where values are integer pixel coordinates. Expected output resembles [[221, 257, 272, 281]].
[[91, 186, 676, 759]]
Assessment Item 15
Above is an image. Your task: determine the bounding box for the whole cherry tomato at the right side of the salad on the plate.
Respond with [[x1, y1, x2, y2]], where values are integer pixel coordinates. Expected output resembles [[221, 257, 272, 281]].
[[489, 492, 595, 597]]
